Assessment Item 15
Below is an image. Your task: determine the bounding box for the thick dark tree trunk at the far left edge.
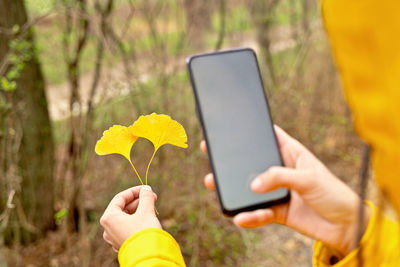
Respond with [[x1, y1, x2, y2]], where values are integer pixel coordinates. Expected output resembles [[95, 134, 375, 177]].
[[0, 0, 54, 243]]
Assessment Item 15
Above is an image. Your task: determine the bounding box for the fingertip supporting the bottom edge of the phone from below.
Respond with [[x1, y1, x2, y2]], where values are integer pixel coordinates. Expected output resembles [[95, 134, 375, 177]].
[[233, 209, 274, 228]]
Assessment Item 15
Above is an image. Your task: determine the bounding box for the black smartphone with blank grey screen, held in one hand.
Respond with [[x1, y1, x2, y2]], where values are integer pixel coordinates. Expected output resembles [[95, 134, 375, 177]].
[[187, 48, 290, 216]]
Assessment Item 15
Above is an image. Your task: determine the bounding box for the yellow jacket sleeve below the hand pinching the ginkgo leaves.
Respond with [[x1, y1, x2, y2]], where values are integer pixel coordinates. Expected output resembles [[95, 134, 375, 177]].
[[118, 228, 186, 267]]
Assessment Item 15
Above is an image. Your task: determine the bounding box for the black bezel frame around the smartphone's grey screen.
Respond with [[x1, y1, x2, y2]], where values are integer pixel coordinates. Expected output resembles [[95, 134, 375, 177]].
[[186, 47, 290, 216]]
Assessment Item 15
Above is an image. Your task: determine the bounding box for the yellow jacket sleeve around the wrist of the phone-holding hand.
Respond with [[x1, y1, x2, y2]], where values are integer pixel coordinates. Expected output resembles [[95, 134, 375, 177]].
[[313, 202, 400, 267]]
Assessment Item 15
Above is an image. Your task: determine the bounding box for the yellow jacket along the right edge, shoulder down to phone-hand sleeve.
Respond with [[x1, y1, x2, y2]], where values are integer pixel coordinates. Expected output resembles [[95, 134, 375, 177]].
[[313, 0, 400, 266]]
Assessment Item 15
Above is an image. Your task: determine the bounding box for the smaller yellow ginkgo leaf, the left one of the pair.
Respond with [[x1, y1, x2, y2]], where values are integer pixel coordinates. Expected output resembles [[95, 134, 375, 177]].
[[95, 125, 139, 162]]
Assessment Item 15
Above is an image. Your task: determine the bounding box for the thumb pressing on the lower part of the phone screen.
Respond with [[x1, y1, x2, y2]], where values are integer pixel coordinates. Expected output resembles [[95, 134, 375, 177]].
[[251, 167, 315, 194]]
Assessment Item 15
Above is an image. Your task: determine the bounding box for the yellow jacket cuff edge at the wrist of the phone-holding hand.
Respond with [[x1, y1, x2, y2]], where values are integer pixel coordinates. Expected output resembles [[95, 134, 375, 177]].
[[313, 201, 378, 267]]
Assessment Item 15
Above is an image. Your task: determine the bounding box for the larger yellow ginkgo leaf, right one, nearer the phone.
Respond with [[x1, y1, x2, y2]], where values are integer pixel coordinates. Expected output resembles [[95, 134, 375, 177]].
[[129, 113, 188, 152]]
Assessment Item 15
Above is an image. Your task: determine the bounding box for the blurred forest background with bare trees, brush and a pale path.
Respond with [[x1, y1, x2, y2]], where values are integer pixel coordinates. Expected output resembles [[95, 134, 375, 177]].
[[0, 0, 372, 267]]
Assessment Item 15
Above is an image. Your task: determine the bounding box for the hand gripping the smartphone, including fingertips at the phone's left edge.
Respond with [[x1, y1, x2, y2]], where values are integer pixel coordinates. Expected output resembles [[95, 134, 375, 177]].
[[200, 126, 371, 255]]
